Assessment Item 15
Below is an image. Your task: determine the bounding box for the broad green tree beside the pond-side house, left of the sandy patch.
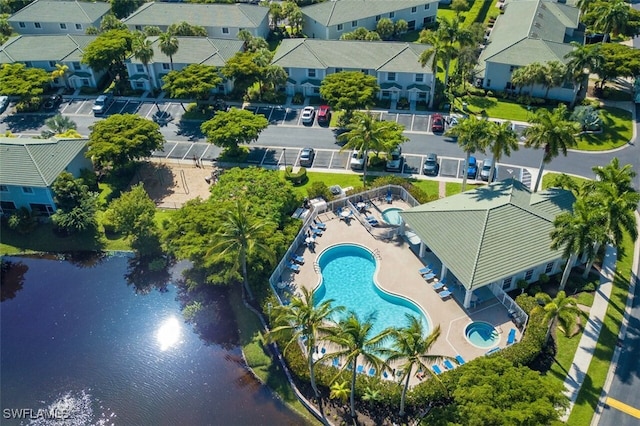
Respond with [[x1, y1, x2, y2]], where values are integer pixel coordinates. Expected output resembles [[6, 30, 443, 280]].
[[86, 114, 164, 170]]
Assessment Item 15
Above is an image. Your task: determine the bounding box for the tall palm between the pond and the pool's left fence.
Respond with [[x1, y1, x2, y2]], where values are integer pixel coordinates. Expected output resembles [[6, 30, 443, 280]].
[[207, 200, 275, 300]]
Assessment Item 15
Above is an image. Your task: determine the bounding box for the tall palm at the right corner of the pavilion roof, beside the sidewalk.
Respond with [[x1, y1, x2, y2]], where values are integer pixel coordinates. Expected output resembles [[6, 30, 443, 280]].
[[550, 198, 600, 290]]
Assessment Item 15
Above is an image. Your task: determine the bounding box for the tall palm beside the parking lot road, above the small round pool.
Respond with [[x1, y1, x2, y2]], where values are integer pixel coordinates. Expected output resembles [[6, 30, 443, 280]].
[[338, 112, 396, 186]]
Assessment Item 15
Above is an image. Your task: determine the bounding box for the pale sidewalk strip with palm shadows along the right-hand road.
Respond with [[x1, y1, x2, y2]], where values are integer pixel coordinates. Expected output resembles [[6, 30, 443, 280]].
[[561, 241, 618, 422]]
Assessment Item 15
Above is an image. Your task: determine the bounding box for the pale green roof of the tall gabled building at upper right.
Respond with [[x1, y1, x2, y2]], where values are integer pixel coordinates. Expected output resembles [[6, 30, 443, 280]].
[[478, 0, 579, 70]]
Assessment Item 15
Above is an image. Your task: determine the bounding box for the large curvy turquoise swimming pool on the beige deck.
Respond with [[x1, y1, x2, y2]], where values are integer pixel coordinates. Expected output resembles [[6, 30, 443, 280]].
[[314, 244, 430, 336]]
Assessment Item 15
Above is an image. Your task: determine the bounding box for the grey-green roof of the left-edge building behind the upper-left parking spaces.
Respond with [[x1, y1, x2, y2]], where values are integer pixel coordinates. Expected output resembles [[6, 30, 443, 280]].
[[0, 34, 96, 64]]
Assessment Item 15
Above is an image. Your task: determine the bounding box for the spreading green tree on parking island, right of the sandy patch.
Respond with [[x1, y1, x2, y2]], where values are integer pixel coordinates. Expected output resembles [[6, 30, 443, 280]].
[[200, 108, 269, 156]]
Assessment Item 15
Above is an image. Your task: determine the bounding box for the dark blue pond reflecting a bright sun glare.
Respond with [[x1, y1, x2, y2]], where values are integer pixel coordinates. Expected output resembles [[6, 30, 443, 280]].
[[0, 255, 304, 425]]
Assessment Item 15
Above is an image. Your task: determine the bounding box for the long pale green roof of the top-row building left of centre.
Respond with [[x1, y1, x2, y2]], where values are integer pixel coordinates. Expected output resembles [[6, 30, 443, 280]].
[[122, 2, 269, 29]]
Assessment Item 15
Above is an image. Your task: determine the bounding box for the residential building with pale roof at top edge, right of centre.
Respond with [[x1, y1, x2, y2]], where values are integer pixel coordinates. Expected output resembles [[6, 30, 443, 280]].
[[302, 0, 438, 40]]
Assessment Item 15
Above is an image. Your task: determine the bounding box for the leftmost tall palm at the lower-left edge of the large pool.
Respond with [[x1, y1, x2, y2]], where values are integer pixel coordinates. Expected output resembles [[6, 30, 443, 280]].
[[268, 287, 344, 412]]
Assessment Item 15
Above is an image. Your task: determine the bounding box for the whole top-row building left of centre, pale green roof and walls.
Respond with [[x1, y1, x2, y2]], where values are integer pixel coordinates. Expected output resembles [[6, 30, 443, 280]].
[[122, 2, 269, 40]]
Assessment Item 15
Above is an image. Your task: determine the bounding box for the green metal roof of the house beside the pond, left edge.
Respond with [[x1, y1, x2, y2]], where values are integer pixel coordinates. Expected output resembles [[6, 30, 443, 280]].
[[0, 137, 88, 187]]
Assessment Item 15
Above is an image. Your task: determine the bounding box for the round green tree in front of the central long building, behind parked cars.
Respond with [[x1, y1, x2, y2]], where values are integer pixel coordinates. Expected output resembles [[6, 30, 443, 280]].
[[320, 71, 380, 121]]
